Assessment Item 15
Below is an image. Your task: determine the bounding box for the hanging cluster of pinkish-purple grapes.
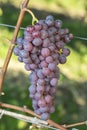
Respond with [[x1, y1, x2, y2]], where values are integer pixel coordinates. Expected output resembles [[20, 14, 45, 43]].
[[14, 15, 73, 120]]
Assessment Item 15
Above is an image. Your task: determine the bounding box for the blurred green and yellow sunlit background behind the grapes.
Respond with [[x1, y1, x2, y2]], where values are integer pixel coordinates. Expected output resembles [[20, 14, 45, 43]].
[[0, 0, 87, 130]]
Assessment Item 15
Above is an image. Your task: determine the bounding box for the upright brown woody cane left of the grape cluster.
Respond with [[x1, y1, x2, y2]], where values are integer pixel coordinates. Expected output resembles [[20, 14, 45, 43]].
[[0, 0, 29, 95]]
